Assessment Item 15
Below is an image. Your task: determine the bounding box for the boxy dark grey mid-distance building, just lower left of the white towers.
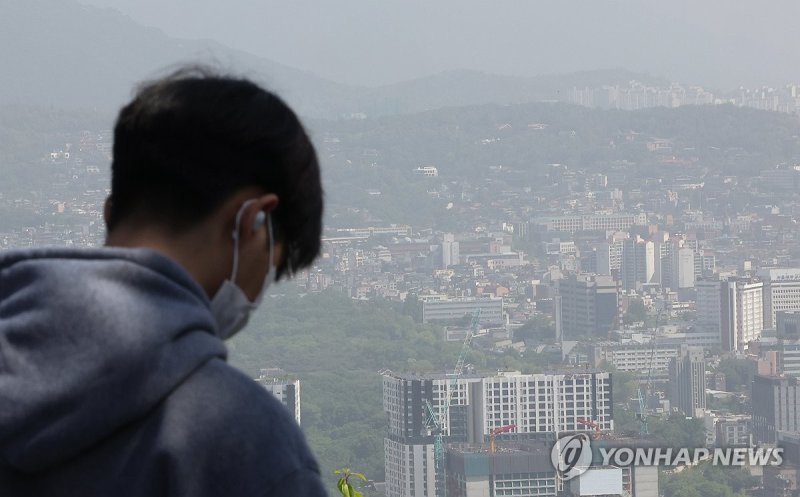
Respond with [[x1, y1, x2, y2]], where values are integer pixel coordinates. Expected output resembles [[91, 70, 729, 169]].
[[556, 273, 620, 339]]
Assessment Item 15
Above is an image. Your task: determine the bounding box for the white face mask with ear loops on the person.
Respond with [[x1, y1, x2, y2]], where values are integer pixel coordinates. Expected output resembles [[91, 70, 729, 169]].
[[211, 200, 278, 340]]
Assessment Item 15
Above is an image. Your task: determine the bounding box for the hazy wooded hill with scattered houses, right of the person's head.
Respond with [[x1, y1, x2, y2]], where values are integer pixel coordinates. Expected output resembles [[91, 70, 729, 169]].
[[311, 103, 800, 230]]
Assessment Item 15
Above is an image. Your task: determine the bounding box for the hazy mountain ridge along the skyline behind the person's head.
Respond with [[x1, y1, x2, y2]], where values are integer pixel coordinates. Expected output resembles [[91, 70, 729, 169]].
[[0, 0, 708, 119]]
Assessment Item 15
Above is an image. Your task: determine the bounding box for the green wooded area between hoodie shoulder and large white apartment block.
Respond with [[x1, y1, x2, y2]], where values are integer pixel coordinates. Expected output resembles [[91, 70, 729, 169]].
[[229, 284, 552, 481]]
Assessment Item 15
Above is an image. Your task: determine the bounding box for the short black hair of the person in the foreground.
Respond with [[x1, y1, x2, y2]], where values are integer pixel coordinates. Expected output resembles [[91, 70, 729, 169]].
[[108, 67, 323, 274]]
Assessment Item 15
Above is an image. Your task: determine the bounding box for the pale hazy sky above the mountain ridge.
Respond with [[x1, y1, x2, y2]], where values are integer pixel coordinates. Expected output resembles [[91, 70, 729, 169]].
[[81, 0, 800, 89]]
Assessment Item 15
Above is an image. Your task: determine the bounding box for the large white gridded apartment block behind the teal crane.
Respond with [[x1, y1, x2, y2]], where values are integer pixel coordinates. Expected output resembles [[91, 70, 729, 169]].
[[383, 372, 613, 497]]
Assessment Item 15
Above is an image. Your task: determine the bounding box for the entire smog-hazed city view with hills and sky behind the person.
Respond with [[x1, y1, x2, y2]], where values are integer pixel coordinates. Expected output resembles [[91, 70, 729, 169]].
[[0, 0, 800, 497]]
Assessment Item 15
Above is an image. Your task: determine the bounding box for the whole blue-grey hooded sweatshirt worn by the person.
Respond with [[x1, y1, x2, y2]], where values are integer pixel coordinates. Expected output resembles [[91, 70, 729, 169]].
[[0, 248, 325, 497]]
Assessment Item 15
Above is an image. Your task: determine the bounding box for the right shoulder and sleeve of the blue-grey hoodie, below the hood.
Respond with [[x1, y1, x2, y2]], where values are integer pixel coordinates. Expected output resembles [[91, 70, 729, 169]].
[[153, 359, 324, 495]]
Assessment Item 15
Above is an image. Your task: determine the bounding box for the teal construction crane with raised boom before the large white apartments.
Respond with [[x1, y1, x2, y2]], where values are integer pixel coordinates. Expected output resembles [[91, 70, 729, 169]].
[[425, 308, 481, 497]]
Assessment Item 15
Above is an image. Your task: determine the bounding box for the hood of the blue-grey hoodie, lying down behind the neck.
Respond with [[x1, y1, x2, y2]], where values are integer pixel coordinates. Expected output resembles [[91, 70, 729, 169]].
[[0, 248, 225, 473]]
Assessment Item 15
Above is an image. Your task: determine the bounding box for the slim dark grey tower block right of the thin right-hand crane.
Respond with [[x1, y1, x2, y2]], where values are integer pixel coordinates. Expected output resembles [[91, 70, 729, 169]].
[[669, 345, 706, 417]]
